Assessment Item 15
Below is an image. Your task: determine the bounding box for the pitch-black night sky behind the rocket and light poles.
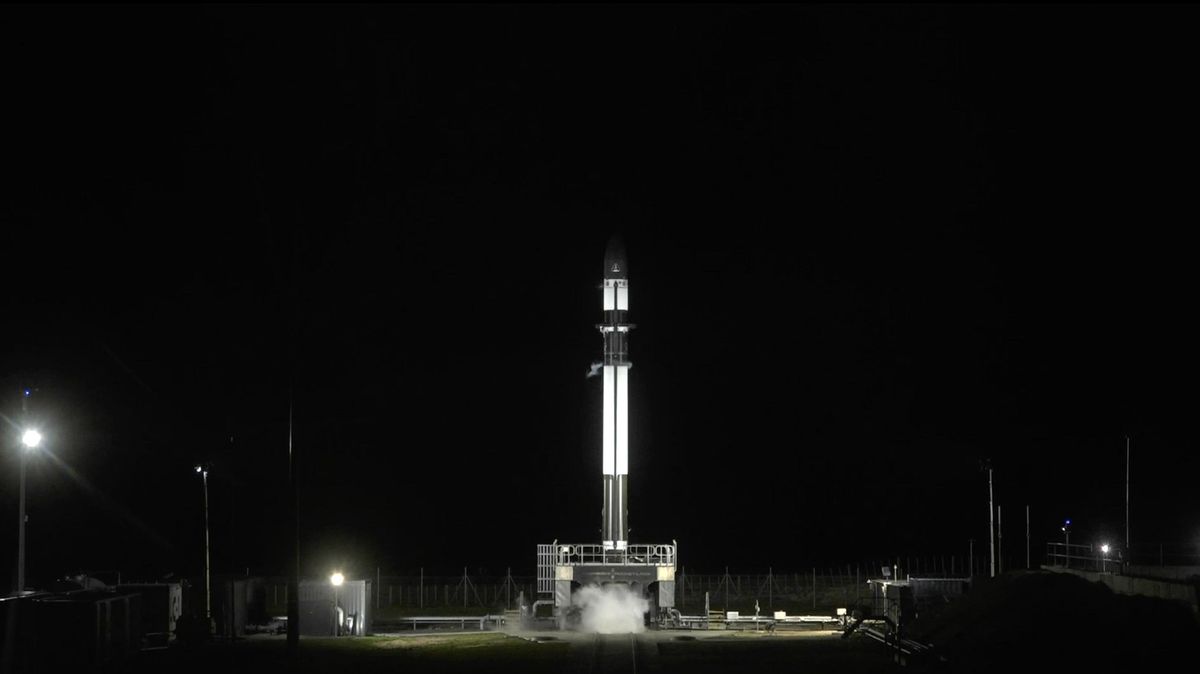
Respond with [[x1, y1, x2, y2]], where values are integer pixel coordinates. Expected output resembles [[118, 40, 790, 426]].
[[0, 6, 1200, 579]]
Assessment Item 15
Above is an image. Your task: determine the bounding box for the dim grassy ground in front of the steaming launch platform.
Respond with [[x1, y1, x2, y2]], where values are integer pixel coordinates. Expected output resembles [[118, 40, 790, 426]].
[[121, 633, 923, 674]]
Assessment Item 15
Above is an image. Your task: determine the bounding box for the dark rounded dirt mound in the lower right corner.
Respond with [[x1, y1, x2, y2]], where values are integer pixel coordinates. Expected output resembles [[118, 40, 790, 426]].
[[906, 572, 1200, 674]]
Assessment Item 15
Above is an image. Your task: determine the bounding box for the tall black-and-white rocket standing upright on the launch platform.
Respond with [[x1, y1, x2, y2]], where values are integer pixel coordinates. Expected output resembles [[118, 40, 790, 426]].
[[596, 237, 634, 550]]
